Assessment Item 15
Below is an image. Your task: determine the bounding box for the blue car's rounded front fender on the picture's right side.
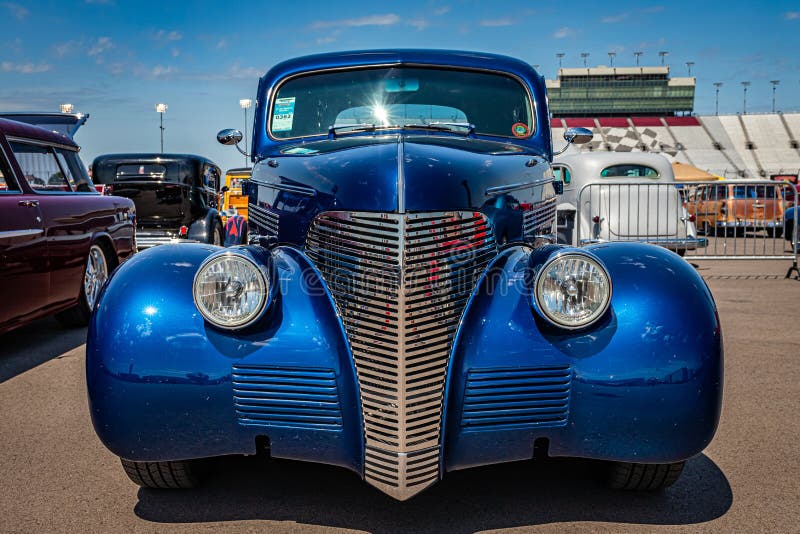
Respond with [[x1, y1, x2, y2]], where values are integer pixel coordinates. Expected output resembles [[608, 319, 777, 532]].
[[444, 243, 723, 470]]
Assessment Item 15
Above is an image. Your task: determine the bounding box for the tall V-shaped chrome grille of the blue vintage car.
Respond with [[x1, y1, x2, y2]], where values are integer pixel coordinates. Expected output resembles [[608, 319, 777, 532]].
[[306, 212, 496, 499]]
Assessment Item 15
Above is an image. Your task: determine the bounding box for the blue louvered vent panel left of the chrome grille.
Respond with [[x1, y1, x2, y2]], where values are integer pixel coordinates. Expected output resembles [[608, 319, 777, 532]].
[[233, 365, 342, 430]]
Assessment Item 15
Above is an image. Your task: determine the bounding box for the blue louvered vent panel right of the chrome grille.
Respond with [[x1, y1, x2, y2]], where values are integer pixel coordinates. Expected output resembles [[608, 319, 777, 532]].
[[461, 366, 572, 430]]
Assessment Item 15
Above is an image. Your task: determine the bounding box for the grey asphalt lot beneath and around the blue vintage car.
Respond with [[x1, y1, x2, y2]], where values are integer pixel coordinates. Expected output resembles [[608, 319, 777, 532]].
[[0, 260, 800, 532]]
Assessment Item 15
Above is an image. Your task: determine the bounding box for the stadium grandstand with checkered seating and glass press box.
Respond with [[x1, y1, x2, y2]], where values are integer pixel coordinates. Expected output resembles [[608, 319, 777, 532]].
[[547, 67, 800, 181]]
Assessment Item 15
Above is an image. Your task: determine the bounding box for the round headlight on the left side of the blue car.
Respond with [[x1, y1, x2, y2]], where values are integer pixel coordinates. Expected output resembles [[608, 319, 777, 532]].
[[192, 253, 269, 328]]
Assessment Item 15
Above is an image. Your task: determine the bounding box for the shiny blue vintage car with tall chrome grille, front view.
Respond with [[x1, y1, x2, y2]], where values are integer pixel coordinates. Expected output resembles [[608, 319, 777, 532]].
[[87, 50, 722, 499]]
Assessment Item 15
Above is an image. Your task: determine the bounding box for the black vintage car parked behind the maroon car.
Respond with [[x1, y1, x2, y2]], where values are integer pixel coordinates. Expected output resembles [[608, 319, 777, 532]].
[[92, 154, 223, 250]]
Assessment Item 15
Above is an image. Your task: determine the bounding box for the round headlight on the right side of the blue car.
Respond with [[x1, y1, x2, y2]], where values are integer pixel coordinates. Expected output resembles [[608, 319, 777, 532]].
[[534, 252, 611, 329]]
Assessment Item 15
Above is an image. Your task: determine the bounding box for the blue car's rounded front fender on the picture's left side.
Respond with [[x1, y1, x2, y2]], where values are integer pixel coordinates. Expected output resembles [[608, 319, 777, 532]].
[[86, 244, 363, 473]]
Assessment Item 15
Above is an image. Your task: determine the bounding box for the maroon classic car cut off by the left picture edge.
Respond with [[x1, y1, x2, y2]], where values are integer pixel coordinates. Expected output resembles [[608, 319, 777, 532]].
[[0, 119, 136, 333]]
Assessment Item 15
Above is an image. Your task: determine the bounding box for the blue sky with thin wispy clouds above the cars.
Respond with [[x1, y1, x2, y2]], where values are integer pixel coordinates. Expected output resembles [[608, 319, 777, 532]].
[[0, 0, 800, 172]]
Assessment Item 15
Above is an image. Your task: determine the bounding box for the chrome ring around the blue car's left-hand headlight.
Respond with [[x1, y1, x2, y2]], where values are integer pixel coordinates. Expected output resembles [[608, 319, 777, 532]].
[[192, 250, 274, 330]]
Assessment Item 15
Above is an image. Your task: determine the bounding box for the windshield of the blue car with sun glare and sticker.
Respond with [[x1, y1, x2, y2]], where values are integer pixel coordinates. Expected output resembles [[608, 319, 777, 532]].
[[270, 67, 535, 139]]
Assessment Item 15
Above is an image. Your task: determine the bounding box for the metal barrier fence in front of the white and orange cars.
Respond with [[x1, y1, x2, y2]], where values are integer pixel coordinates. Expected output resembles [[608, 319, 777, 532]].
[[572, 180, 800, 265]]
